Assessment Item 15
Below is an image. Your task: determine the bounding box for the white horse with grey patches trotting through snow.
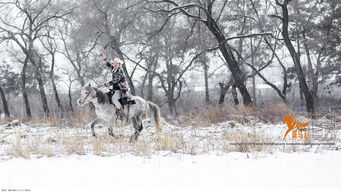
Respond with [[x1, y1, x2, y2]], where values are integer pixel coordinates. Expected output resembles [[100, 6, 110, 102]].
[[77, 83, 161, 142]]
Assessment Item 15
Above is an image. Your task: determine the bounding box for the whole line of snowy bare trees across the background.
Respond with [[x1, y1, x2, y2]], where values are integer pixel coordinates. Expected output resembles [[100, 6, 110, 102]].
[[0, 0, 341, 117]]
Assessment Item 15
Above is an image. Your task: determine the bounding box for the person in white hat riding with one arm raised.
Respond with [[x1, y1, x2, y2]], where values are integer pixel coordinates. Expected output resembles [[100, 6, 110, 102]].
[[100, 52, 129, 114]]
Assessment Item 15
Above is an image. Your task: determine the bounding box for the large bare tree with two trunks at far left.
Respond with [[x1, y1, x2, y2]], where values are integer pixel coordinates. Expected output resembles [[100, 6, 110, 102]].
[[0, 0, 70, 116]]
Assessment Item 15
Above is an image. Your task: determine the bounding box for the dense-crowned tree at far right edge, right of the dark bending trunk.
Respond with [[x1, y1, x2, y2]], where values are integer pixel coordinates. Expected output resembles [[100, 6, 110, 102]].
[[291, 0, 340, 110]]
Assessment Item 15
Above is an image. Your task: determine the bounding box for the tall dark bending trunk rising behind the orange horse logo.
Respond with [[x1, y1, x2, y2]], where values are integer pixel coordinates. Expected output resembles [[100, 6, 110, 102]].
[[276, 0, 315, 116]]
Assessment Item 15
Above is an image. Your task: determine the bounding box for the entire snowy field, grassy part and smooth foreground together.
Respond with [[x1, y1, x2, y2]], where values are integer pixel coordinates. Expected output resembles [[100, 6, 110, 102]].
[[0, 119, 341, 191]]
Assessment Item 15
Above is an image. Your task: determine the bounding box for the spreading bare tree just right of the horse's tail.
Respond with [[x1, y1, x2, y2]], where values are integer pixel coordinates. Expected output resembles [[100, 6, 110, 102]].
[[126, 20, 203, 114]]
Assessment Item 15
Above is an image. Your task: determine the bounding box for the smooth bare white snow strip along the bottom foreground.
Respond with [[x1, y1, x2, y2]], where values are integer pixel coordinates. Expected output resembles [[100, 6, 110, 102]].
[[0, 151, 341, 191]]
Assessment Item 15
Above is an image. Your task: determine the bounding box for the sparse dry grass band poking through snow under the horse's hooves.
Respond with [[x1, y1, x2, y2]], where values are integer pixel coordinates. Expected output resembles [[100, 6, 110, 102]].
[[3, 122, 334, 158]]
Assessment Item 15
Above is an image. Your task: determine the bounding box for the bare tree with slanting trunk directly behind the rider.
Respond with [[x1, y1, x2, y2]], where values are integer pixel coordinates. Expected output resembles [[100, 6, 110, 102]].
[[78, 0, 146, 95]]
